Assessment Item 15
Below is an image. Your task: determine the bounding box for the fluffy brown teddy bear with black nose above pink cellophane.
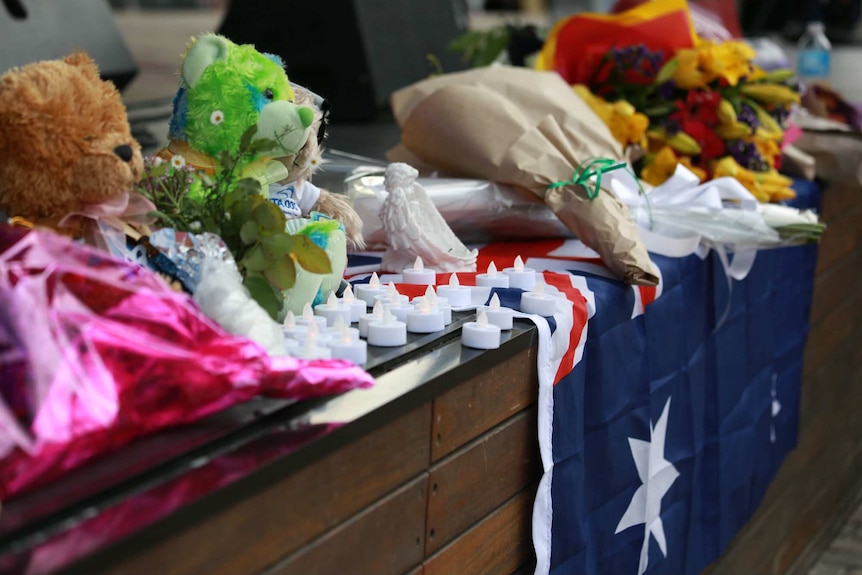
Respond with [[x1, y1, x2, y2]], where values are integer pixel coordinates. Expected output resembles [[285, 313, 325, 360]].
[[0, 52, 143, 235]]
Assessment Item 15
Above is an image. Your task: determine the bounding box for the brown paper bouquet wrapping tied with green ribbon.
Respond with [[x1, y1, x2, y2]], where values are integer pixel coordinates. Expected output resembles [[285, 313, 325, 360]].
[[389, 67, 658, 285]]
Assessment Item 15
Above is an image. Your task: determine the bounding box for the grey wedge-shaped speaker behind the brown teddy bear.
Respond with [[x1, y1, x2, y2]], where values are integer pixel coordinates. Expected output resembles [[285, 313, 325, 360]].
[[0, 0, 138, 90]]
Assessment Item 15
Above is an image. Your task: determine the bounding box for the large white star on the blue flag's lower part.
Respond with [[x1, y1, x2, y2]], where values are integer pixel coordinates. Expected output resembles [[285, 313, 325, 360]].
[[614, 398, 679, 575]]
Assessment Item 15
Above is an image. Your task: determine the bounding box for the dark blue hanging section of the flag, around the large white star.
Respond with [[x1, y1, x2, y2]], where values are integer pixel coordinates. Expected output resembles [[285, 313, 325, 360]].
[[551, 237, 816, 575]]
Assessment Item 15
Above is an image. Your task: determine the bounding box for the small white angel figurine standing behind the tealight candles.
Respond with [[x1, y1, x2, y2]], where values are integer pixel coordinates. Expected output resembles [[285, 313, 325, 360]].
[[380, 163, 478, 272]]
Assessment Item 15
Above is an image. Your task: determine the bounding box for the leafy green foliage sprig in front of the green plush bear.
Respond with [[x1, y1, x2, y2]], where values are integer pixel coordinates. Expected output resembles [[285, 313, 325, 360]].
[[138, 126, 332, 318]]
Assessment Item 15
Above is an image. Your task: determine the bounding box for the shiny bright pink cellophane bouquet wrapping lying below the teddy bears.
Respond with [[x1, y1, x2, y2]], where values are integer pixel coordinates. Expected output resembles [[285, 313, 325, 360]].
[[0, 225, 373, 499]]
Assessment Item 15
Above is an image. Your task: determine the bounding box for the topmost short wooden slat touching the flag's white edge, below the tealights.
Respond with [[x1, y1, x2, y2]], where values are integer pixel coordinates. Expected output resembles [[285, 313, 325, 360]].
[[431, 348, 539, 461]]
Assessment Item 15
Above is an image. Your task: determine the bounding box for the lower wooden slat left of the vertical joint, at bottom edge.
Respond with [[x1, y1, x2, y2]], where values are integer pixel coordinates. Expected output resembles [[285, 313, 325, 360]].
[[266, 474, 428, 575]]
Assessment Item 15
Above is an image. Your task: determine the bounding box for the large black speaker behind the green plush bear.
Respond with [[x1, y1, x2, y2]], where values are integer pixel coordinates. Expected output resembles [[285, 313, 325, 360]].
[[219, 0, 467, 121]]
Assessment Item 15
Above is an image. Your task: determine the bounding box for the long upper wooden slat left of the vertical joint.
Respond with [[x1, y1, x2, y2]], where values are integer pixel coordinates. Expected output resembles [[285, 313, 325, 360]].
[[106, 404, 431, 575]]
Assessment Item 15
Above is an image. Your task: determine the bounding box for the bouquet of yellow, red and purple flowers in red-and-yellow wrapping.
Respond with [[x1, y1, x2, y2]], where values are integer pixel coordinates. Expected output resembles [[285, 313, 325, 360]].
[[536, 0, 799, 202]]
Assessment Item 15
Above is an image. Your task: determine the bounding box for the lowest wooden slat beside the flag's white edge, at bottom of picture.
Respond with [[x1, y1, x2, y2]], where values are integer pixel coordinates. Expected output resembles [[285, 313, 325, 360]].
[[424, 484, 536, 575]]
